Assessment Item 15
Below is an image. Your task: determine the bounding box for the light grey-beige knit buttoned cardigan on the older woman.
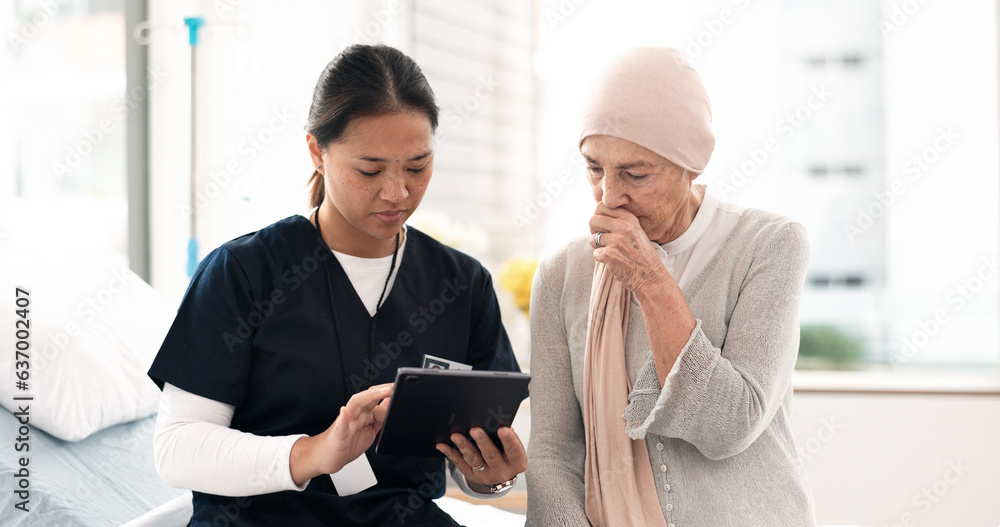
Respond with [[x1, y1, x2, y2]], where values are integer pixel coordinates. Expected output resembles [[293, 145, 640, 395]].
[[525, 209, 815, 527]]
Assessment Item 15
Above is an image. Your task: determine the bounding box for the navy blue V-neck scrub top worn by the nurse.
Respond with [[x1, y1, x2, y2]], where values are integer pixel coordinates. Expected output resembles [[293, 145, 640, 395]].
[[149, 216, 520, 527]]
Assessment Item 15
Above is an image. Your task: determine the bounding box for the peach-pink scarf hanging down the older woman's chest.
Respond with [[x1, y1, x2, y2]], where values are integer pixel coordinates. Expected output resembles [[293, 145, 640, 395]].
[[583, 263, 666, 527]]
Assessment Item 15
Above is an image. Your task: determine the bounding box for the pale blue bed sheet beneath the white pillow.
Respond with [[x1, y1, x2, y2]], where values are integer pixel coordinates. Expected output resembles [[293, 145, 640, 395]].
[[0, 407, 185, 527]]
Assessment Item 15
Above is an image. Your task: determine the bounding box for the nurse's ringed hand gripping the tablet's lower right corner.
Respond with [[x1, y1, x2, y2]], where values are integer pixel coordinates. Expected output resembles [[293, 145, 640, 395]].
[[437, 426, 528, 493]]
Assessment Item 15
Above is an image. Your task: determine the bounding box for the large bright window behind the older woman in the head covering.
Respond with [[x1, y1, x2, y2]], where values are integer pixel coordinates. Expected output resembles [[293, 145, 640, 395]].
[[537, 0, 1000, 371]]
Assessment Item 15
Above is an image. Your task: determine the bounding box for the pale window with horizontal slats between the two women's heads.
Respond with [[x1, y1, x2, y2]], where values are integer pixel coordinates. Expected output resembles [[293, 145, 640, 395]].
[[412, 0, 536, 265]]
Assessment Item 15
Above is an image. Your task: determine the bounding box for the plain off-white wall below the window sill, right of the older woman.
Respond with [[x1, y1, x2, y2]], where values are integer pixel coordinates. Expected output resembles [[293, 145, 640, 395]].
[[792, 393, 1000, 527]]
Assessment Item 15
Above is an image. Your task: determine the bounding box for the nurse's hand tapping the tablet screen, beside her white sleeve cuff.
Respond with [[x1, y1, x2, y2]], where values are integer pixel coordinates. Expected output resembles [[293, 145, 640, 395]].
[[289, 383, 392, 485]]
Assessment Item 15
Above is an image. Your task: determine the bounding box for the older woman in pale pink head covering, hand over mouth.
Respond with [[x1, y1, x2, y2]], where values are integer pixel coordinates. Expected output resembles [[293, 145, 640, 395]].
[[527, 48, 815, 527]]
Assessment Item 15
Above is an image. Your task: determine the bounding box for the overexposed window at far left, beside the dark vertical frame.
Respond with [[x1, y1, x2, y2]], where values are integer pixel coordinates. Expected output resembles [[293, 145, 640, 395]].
[[0, 0, 128, 265]]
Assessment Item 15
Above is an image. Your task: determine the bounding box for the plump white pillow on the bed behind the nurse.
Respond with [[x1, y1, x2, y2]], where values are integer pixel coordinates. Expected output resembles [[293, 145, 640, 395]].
[[0, 253, 175, 441]]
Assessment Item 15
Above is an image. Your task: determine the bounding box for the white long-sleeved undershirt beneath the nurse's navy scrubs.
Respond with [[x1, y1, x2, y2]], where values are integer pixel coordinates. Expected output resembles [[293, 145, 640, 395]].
[[153, 223, 507, 499]]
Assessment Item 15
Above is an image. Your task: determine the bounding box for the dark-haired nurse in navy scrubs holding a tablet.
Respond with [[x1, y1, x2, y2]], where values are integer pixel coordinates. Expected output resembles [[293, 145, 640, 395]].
[[149, 45, 526, 526]]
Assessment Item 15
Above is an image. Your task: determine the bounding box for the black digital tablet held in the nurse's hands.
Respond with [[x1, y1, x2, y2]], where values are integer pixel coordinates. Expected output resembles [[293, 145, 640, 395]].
[[375, 368, 531, 457]]
